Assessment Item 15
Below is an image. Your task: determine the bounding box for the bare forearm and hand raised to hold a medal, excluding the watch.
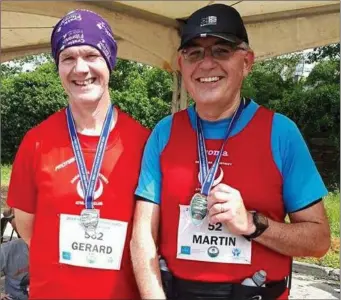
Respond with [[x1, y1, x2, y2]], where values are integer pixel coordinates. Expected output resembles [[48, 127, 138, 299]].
[[208, 184, 330, 257]]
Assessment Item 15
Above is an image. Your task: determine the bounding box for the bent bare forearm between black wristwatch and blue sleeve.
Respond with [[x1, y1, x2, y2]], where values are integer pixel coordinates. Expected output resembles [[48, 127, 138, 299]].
[[255, 201, 330, 257]]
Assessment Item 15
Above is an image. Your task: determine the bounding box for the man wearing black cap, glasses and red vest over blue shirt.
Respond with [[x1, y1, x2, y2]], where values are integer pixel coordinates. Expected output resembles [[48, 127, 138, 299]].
[[131, 4, 330, 299]]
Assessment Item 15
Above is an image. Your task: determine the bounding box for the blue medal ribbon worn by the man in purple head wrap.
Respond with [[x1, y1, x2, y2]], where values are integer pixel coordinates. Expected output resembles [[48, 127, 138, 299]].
[[66, 105, 114, 209]]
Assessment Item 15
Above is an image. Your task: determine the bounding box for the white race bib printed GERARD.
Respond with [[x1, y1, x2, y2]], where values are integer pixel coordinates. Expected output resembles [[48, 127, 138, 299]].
[[59, 214, 128, 270]]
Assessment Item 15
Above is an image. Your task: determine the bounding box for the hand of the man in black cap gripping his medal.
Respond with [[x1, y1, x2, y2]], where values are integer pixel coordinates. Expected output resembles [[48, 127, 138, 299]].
[[207, 183, 256, 235]]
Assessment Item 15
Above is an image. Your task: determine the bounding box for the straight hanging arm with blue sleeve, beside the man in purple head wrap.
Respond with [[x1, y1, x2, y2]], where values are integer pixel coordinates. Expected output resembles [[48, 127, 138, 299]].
[[130, 116, 172, 299]]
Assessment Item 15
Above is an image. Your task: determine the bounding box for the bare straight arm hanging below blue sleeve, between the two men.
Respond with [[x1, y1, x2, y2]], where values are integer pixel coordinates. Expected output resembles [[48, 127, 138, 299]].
[[130, 201, 166, 299]]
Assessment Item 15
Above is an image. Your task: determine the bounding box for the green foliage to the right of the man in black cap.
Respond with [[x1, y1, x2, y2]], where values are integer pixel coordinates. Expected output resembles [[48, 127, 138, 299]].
[[242, 55, 340, 187]]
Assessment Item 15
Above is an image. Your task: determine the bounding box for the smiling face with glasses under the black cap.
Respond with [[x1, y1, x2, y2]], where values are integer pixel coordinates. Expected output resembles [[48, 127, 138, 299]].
[[178, 37, 254, 105]]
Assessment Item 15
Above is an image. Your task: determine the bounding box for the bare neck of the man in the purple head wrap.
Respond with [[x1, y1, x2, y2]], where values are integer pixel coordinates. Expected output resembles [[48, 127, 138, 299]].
[[70, 93, 117, 135]]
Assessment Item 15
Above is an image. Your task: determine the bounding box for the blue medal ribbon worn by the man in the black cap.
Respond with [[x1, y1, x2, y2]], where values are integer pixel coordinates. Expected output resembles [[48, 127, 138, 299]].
[[196, 99, 245, 197]]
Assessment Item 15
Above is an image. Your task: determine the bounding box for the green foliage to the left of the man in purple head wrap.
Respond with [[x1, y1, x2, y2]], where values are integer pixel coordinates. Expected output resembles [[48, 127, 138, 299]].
[[0, 63, 66, 162]]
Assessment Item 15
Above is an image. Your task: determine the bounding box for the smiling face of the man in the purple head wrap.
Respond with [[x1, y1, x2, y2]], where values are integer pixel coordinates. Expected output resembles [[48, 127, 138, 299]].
[[58, 46, 110, 104]]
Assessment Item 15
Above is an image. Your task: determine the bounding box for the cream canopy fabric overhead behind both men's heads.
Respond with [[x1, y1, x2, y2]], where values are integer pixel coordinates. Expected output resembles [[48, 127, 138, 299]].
[[1, 0, 340, 71]]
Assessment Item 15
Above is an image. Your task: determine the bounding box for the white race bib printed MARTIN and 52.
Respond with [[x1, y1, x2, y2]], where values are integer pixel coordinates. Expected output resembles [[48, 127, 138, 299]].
[[176, 205, 252, 264]]
